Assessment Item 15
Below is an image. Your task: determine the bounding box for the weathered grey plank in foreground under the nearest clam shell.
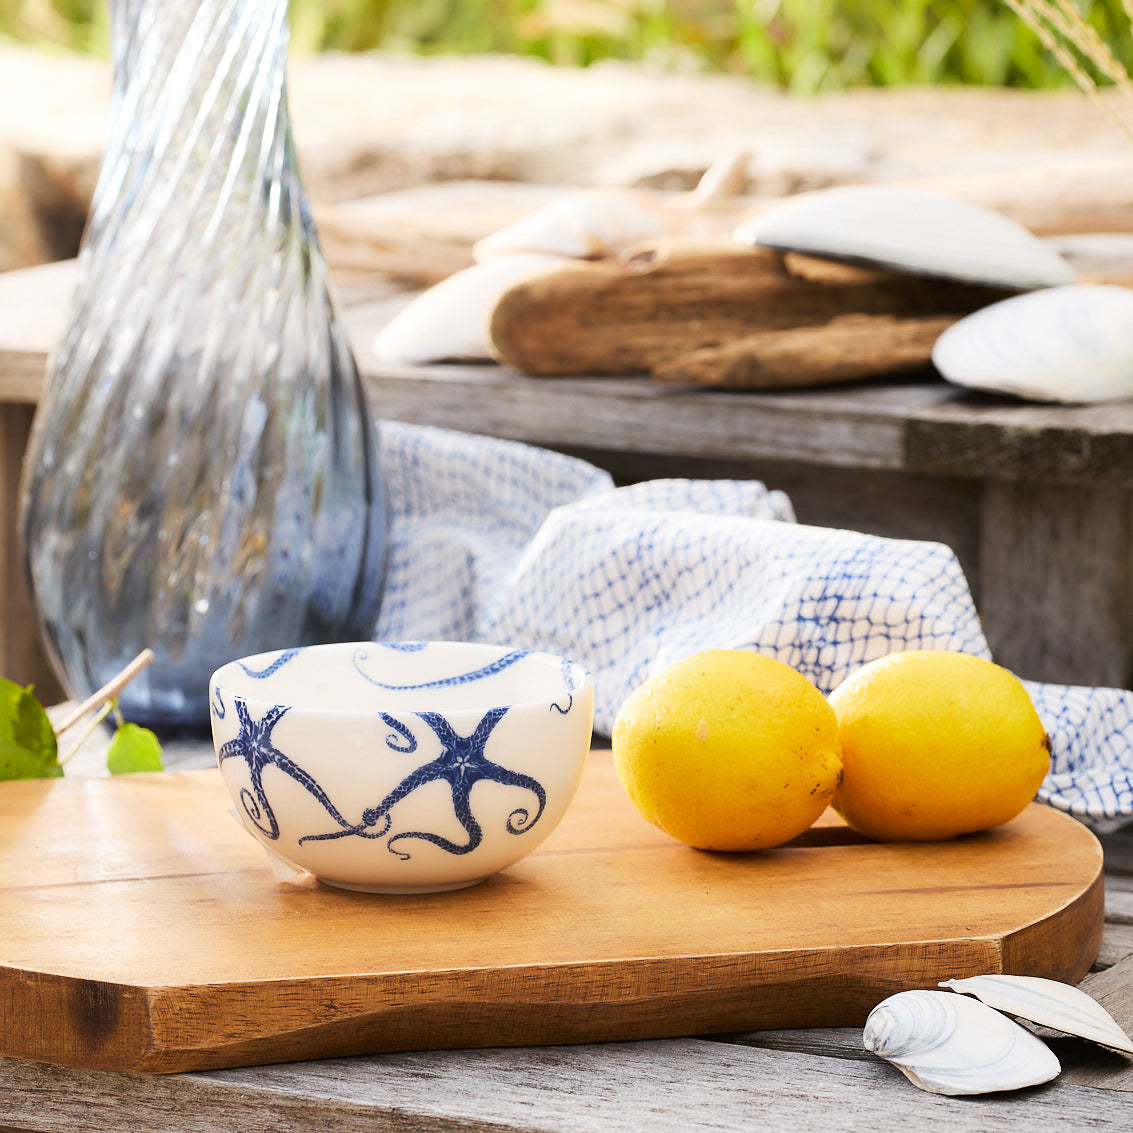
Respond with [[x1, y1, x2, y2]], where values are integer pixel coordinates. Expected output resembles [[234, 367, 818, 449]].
[[169, 1039, 1133, 1133]]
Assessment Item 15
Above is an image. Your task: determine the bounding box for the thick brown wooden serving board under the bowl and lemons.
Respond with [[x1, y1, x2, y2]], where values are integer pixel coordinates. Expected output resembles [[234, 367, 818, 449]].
[[0, 752, 1104, 1073]]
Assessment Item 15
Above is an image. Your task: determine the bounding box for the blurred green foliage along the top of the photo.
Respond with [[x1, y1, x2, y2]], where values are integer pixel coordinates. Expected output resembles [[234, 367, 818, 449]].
[[0, 0, 1133, 93]]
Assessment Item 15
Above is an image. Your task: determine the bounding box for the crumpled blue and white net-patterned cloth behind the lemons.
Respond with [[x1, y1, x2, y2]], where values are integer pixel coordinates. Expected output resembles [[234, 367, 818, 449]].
[[374, 421, 1133, 829]]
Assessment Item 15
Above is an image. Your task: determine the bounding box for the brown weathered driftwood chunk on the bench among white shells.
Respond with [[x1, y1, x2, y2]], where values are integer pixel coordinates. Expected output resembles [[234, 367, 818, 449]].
[[489, 244, 1006, 389]]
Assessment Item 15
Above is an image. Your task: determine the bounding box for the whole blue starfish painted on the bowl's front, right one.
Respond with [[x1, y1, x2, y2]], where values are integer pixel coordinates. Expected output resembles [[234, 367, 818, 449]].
[[299, 708, 547, 860]]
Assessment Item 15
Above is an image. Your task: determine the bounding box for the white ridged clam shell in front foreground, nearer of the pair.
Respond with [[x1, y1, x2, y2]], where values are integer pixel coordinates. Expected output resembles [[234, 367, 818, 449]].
[[862, 991, 1062, 1094]]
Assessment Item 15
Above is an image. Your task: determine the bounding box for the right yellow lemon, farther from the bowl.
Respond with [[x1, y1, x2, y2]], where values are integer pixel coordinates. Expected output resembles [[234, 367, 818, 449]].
[[829, 649, 1050, 842]]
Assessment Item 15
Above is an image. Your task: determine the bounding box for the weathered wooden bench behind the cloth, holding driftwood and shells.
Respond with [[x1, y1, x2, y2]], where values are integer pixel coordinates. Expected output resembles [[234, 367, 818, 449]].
[[0, 263, 1133, 702]]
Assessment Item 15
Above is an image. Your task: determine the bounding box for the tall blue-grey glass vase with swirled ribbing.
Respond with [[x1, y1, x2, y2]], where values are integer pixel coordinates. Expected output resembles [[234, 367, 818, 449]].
[[22, 0, 386, 733]]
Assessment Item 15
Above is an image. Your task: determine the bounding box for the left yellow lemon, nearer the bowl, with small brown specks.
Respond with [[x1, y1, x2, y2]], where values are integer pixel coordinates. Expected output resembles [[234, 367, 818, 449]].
[[612, 649, 842, 850]]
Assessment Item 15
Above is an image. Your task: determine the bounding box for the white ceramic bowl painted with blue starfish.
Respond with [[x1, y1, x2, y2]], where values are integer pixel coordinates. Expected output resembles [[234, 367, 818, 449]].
[[210, 641, 594, 893]]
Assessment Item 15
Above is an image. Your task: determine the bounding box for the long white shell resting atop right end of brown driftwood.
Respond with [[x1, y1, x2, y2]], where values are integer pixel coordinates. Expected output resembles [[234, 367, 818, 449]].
[[733, 185, 1076, 291]]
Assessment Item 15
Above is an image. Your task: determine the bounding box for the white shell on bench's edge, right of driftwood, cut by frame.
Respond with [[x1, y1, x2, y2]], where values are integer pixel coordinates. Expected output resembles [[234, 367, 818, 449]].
[[932, 283, 1133, 403]]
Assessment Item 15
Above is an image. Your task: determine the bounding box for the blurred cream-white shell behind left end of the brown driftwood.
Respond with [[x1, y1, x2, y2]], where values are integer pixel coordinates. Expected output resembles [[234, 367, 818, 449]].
[[472, 188, 675, 263]]
